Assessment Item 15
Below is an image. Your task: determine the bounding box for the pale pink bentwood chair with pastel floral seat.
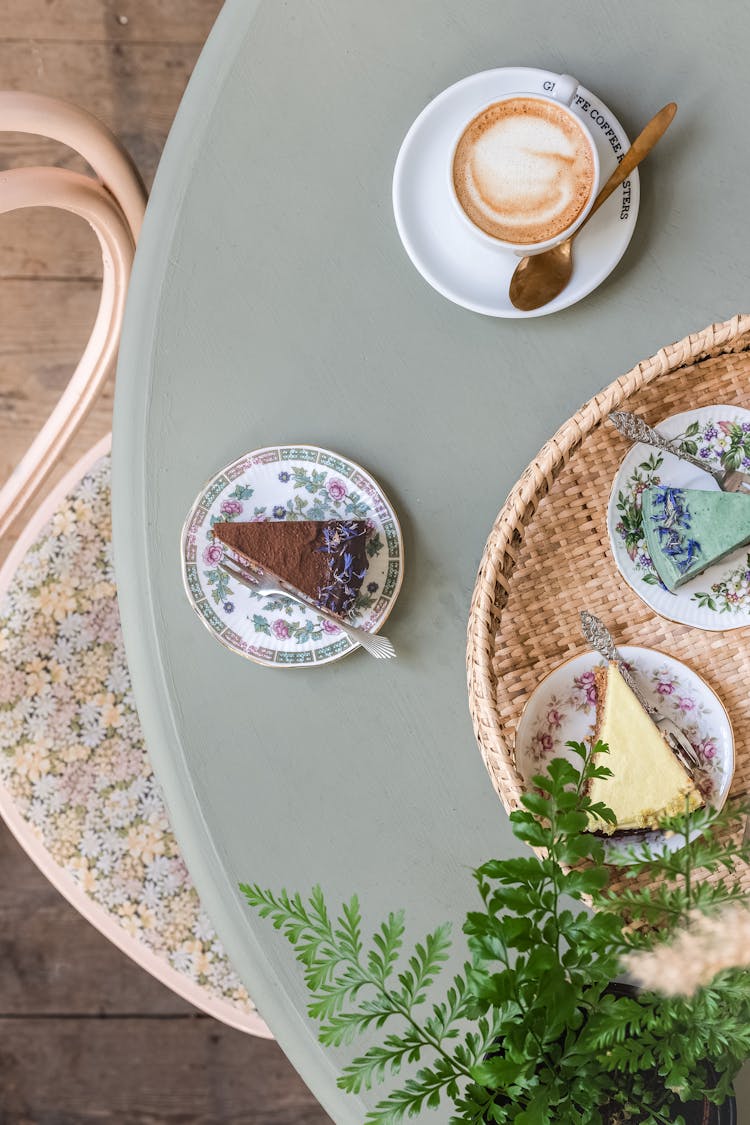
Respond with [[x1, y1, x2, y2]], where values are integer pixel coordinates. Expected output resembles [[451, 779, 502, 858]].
[[0, 92, 270, 1037]]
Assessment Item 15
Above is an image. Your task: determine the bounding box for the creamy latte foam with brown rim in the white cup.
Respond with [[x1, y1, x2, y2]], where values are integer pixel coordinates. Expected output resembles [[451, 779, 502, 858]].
[[453, 98, 595, 245]]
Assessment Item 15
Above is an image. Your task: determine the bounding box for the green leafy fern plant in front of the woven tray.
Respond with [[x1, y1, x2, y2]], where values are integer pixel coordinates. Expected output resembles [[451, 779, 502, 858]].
[[241, 743, 750, 1125]]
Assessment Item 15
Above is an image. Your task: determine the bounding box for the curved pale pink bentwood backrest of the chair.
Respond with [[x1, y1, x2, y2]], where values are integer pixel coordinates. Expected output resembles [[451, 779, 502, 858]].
[[0, 91, 146, 537]]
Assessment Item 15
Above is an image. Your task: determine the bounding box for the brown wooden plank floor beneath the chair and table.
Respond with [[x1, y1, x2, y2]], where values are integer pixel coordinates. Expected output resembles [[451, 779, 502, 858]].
[[0, 0, 328, 1125]]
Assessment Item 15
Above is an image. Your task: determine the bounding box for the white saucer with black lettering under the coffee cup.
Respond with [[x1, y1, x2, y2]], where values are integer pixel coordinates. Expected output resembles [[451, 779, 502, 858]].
[[394, 66, 640, 317]]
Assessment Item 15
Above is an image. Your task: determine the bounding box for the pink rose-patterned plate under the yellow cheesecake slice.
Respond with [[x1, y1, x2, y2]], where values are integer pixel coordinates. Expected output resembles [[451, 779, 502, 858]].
[[516, 645, 734, 851]]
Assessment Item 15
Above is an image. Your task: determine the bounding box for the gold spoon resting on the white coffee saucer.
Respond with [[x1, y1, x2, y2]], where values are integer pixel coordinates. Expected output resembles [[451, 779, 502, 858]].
[[509, 101, 677, 313]]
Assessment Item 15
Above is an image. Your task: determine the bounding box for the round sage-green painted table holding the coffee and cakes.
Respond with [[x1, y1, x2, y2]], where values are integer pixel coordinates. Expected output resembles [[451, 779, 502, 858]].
[[114, 0, 750, 1125]]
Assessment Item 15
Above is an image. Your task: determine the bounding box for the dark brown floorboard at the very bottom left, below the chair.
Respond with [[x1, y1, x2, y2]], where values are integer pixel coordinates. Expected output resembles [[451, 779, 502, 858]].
[[0, 1017, 329, 1125]]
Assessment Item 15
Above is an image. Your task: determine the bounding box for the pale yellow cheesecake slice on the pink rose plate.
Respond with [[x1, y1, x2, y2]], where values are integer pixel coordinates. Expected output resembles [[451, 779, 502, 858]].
[[588, 663, 704, 835]]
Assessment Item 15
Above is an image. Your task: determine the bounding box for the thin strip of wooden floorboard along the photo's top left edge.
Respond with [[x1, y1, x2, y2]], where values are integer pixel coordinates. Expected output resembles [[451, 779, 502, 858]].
[[0, 0, 222, 45]]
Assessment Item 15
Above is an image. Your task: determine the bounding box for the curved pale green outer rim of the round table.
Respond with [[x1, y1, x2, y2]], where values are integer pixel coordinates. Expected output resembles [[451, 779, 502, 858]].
[[112, 0, 367, 1125]]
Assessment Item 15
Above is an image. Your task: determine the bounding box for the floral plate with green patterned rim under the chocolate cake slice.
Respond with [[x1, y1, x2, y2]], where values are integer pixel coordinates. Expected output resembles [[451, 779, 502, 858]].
[[181, 446, 404, 668]]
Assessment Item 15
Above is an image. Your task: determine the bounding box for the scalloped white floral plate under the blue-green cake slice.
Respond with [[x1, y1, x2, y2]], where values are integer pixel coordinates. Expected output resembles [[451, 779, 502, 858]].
[[607, 406, 750, 630]]
